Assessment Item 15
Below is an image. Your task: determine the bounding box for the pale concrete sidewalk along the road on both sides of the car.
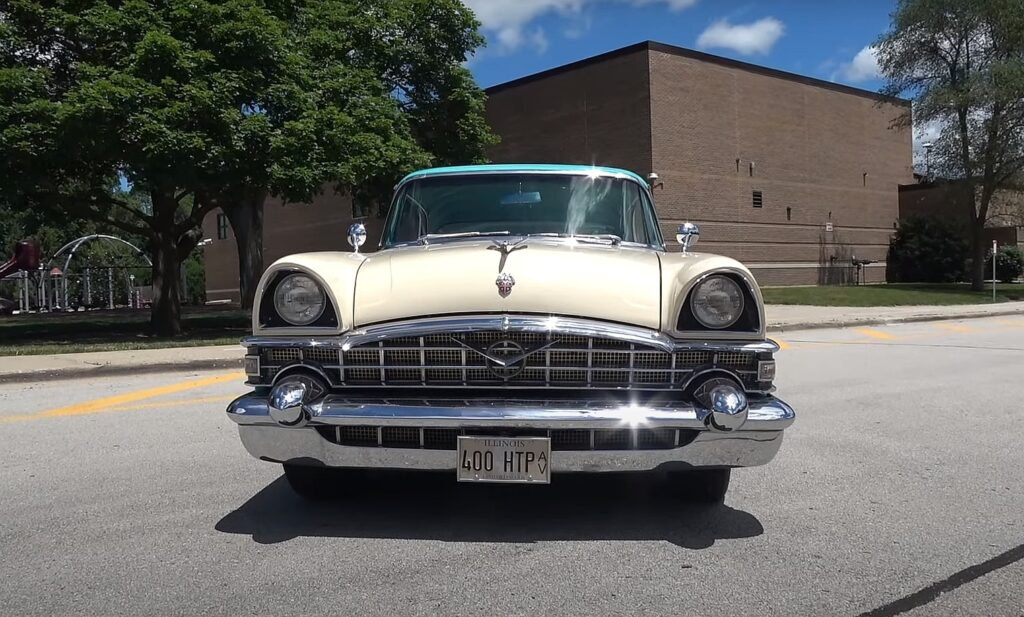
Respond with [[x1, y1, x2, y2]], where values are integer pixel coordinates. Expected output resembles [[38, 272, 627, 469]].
[[0, 302, 1024, 384]]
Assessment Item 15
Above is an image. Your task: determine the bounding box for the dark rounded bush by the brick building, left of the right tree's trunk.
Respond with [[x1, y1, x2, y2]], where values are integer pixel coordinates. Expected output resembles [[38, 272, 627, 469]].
[[889, 217, 970, 282]]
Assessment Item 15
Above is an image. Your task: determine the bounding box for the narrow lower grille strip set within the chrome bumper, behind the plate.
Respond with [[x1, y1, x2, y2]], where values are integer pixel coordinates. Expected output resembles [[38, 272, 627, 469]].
[[316, 426, 698, 451]]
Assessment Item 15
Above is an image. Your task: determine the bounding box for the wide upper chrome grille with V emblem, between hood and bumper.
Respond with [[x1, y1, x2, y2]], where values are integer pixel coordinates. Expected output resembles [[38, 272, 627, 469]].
[[251, 330, 757, 390]]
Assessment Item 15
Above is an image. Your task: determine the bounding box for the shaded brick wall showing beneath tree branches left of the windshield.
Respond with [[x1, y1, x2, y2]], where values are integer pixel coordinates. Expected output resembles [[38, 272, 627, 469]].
[[203, 189, 383, 302]]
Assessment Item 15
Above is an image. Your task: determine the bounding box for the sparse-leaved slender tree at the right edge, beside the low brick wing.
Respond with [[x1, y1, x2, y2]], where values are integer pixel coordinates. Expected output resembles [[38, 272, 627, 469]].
[[878, 0, 1024, 290]]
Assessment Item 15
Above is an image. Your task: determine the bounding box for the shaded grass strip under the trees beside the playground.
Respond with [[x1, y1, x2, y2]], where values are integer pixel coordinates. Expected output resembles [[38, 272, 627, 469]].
[[0, 308, 250, 356]]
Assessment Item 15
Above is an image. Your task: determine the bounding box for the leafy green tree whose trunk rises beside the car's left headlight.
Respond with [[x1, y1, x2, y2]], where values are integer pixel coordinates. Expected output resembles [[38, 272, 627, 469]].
[[218, 0, 495, 306]]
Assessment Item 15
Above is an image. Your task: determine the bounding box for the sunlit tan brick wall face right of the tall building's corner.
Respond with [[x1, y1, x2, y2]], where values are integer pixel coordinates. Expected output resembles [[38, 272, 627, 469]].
[[650, 50, 912, 284]]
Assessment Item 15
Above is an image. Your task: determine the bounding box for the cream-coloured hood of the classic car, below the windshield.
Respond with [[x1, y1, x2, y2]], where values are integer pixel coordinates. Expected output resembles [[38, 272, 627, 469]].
[[352, 238, 662, 328]]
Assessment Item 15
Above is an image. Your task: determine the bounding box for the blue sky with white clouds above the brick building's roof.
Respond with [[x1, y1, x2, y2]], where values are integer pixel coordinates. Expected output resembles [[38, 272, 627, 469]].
[[464, 0, 894, 90]]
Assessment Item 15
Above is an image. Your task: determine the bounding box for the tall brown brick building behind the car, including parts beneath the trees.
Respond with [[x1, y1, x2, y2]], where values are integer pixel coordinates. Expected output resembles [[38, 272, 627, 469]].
[[199, 42, 913, 299]]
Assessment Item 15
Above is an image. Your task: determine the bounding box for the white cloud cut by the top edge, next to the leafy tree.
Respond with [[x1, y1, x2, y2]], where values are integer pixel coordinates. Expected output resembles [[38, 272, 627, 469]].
[[463, 0, 697, 53]]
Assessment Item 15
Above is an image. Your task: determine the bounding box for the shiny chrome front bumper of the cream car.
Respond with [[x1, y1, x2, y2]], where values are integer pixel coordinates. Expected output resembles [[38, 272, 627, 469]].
[[227, 394, 795, 472]]
